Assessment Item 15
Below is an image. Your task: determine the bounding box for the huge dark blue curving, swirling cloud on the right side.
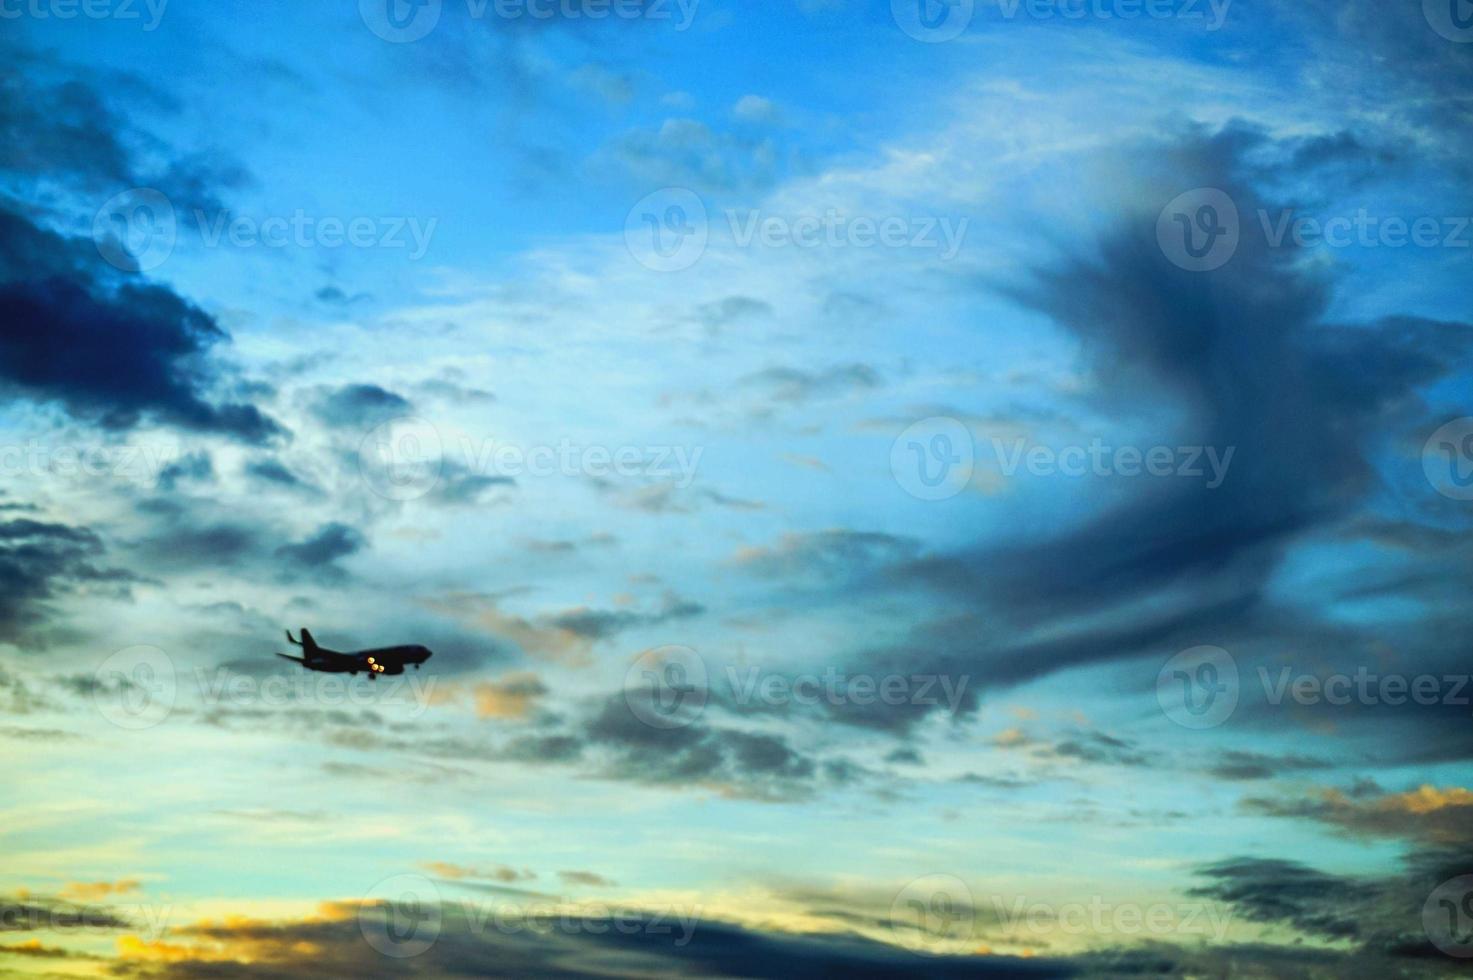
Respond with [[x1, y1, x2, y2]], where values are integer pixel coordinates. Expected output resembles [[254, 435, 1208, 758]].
[[818, 124, 1473, 710]]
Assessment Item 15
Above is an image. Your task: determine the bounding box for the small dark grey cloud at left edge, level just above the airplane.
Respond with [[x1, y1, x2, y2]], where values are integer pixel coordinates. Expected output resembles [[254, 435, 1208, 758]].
[[0, 519, 141, 643]]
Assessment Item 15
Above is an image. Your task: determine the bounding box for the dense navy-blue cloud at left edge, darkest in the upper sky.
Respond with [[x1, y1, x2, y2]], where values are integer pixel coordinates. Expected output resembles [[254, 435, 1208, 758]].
[[0, 209, 283, 444]]
